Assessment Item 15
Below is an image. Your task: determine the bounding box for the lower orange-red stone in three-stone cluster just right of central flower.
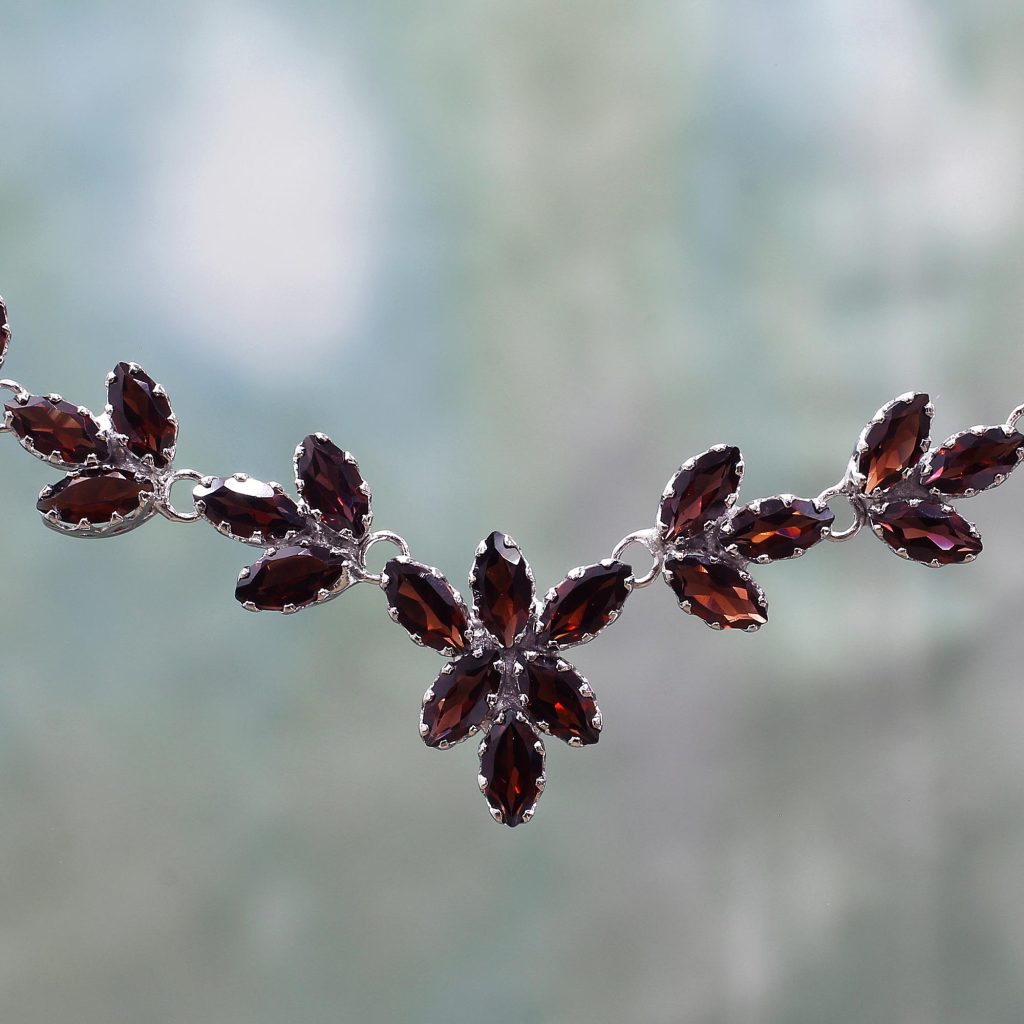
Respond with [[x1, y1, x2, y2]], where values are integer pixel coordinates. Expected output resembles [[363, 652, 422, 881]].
[[665, 554, 768, 632]]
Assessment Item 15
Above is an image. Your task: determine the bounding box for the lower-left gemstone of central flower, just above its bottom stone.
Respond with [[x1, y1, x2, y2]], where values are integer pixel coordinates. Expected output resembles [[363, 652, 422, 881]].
[[420, 650, 502, 748]]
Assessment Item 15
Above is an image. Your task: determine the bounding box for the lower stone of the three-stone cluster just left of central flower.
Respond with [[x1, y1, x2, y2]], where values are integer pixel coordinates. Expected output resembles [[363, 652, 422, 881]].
[[234, 545, 345, 611]]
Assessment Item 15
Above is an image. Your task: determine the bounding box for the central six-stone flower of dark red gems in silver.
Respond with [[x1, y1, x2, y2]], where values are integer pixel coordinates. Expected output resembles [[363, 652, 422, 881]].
[[381, 532, 633, 827]]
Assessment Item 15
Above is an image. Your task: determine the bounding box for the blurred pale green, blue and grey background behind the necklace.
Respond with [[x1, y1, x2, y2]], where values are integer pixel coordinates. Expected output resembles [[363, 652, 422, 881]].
[[0, 0, 1024, 1024]]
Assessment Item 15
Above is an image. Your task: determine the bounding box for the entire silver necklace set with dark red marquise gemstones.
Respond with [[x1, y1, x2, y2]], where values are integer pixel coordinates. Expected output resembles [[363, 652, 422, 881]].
[[0, 299, 1024, 826]]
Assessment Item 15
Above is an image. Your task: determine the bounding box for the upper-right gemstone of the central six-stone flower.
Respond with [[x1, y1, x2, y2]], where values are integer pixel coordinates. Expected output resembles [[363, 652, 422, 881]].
[[538, 558, 633, 647]]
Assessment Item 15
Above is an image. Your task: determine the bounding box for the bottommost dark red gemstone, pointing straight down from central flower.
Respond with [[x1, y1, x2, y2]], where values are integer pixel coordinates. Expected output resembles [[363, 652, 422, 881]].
[[480, 712, 544, 828]]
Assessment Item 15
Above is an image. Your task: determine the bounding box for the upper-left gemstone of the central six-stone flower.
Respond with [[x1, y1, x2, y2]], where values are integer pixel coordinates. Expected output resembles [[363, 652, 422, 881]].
[[384, 557, 469, 652]]
